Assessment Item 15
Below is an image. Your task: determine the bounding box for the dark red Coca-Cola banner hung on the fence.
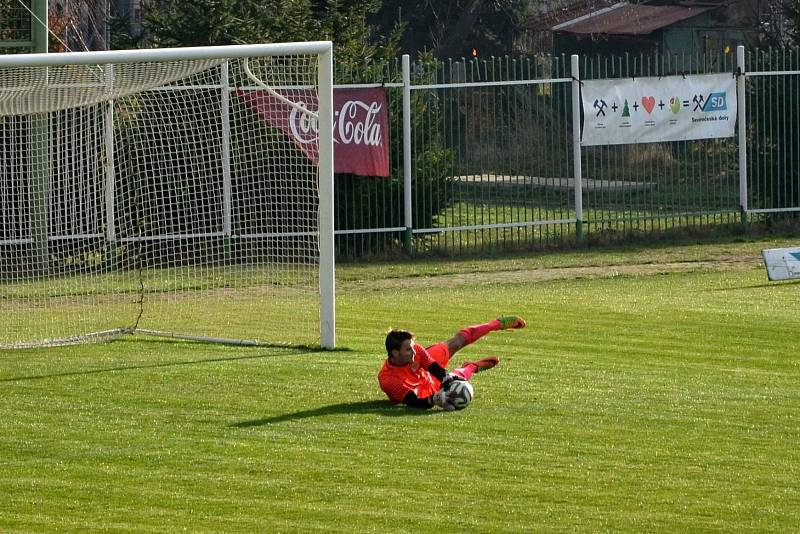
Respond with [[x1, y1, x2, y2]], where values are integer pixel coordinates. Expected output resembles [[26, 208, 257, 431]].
[[236, 87, 389, 176]]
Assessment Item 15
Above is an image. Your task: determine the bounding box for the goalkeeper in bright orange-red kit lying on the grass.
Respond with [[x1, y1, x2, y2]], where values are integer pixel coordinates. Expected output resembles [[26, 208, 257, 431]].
[[378, 315, 525, 410]]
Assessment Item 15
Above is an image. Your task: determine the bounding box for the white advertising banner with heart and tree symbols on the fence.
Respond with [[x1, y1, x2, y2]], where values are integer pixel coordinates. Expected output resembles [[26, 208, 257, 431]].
[[581, 73, 736, 146]]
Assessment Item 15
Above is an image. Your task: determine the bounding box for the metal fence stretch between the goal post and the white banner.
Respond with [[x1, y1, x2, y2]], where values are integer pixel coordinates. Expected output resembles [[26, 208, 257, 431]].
[[336, 57, 575, 258]]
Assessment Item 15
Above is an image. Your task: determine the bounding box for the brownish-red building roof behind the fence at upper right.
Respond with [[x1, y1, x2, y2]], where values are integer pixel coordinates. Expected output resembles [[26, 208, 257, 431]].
[[550, 2, 717, 35]]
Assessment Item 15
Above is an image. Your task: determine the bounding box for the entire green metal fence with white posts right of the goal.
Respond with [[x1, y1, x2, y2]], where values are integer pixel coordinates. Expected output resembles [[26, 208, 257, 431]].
[[336, 49, 800, 258]]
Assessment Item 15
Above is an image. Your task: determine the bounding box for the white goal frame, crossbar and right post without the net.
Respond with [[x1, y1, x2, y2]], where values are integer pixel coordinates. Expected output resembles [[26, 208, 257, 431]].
[[0, 41, 336, 349]]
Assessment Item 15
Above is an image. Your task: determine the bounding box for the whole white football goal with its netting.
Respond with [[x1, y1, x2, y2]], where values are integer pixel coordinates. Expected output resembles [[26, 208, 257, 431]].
[[0, 42, 335, 349]]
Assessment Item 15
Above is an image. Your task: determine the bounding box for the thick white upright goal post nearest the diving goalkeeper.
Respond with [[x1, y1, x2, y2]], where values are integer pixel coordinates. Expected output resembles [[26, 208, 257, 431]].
[[318, 45, 336, 349]]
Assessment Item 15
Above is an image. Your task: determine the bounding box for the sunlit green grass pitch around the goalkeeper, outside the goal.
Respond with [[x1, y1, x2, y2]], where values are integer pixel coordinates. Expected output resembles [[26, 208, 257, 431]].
[[0, 242, 800, 532]]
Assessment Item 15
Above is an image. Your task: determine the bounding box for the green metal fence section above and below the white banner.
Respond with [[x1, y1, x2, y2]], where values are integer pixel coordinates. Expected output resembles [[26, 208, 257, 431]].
[[581, 53, 740, 243]]
